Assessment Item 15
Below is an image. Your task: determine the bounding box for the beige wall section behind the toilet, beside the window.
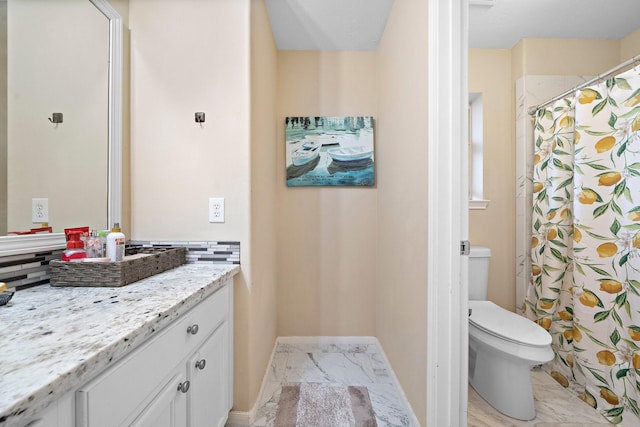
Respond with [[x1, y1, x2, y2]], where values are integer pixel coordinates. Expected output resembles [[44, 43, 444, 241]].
[[469, 49, 516, 310]]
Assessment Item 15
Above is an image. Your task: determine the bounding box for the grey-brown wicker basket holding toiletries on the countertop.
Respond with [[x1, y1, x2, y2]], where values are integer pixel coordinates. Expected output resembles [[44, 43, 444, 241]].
[[49, 248, 186, 287]]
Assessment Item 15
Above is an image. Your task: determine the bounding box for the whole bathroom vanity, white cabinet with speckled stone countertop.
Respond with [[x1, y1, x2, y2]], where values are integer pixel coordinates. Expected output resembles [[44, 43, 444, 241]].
[[0, 264, 239, 427]]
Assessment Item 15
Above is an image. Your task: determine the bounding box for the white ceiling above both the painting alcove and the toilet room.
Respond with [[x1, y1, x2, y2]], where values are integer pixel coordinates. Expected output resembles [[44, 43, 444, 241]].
[[266, 0, 640, 50]]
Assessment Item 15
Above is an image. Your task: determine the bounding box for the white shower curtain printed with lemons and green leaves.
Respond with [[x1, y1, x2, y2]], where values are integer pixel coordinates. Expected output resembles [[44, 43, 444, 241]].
[[524, 68, 640, 426]]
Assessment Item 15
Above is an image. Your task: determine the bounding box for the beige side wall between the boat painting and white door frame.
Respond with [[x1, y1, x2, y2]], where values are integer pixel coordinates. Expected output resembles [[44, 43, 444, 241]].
[[375, 0, 428, 425]]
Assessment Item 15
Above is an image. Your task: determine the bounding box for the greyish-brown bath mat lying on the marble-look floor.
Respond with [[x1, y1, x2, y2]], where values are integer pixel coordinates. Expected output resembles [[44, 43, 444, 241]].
[[274, 383, 378, 427]]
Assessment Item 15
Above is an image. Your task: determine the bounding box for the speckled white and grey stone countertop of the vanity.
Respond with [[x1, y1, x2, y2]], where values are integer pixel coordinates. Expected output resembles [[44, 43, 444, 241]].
[[0, 264, 240, 427]]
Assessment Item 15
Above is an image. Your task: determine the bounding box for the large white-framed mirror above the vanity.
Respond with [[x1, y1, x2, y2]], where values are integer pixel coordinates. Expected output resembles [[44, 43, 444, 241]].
[[0, 0, 122, 256]]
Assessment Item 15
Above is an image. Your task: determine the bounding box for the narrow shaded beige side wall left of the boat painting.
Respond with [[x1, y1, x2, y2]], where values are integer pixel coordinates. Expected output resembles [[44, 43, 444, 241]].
[[248, 0, 282, 416]]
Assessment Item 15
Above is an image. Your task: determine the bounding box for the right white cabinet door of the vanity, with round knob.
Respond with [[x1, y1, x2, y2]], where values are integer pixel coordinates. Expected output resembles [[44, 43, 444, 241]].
[[187, 320, 231, 427]]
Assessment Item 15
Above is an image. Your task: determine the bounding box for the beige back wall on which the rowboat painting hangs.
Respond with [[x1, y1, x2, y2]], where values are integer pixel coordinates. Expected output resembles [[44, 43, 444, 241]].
[[276, 51, 380, 336]]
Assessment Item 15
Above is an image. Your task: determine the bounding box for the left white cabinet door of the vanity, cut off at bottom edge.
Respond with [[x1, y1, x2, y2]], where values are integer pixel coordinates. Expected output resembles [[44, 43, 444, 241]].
[[127, 373, 188, 427]]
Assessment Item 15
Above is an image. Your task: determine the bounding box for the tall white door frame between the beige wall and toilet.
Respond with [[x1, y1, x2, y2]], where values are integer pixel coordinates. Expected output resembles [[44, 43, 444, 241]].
[[427, 0, 468, 427]]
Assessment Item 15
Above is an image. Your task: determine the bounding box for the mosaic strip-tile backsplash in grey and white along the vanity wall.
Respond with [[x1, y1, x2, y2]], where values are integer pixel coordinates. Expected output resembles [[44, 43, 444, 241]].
[[0, 240, 240, 290]]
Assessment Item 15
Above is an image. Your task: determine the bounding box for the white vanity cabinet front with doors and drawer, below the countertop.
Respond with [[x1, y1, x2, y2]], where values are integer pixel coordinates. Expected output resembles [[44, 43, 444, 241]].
[[75, 279, 233, 427]]
